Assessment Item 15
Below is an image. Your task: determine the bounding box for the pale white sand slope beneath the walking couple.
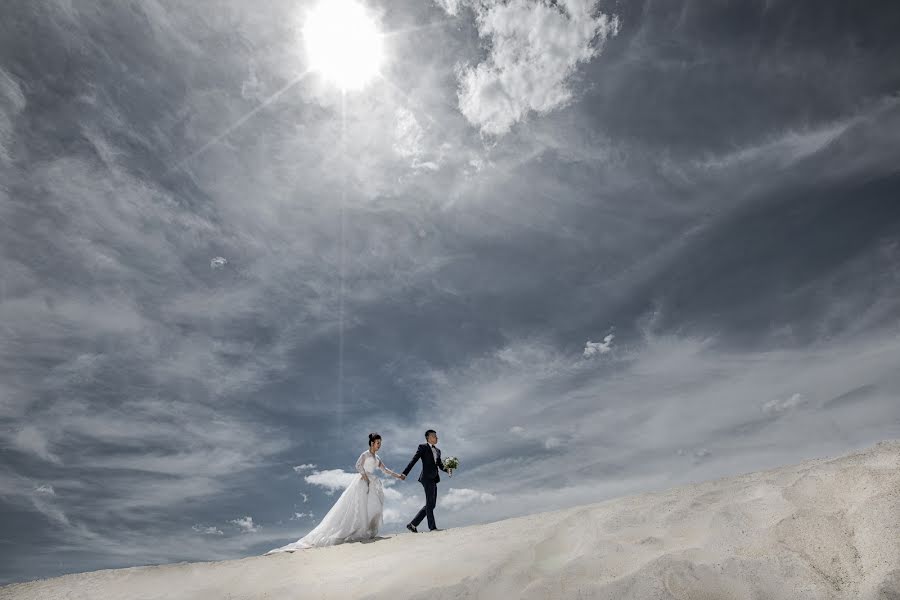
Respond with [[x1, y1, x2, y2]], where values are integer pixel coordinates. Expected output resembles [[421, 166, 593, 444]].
[[0, 441, 900, 600]]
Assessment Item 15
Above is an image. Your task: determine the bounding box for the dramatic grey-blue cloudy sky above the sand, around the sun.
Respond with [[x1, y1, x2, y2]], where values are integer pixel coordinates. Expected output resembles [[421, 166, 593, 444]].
[[0, 0, 900, 584]]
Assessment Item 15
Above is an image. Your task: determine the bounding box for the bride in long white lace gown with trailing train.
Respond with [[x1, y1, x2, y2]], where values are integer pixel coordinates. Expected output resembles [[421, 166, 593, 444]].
[[266, 433, 403, 554]]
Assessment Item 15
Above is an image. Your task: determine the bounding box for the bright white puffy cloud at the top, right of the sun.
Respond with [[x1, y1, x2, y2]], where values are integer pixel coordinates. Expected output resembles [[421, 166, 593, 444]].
[[458, 0, 619, 135]]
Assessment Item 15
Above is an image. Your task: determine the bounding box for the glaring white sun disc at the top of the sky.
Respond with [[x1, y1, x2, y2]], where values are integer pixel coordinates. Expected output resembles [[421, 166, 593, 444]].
[[303, 0, 384, 91]]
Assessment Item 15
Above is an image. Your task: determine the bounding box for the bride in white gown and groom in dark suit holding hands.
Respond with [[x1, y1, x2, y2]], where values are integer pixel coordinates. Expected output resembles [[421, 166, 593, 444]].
[[266, 429, 453, 554]]
